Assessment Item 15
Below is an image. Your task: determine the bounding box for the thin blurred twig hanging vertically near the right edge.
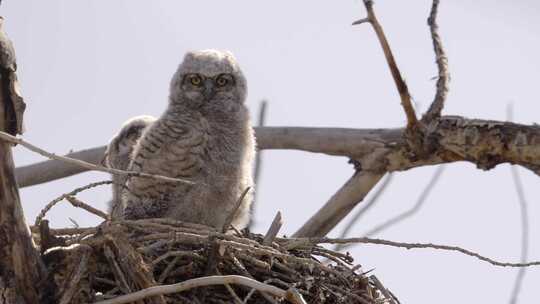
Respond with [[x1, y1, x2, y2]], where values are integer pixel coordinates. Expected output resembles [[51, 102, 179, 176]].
[[510, 166, 529, 304]]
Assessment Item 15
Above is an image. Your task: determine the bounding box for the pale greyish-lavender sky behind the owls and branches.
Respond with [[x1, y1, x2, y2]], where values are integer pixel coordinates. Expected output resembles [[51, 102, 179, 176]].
[[4, 0, 540, 303]]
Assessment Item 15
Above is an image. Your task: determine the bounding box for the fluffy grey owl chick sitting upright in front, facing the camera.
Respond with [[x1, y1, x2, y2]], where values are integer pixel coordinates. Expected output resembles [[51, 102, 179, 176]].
[[123, 50, 255, 228]]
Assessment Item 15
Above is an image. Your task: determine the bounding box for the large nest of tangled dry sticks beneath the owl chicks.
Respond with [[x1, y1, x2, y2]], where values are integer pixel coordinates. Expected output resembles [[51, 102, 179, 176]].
[[33, 219, 393, 304]]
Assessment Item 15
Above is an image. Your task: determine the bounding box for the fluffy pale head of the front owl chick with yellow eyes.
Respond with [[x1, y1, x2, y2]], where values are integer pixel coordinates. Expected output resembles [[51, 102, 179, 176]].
[[170, 50, 247, 111]]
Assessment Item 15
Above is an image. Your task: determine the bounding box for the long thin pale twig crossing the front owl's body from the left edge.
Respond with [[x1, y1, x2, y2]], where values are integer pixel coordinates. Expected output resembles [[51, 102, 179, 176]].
[[0, 131, 194, 184]]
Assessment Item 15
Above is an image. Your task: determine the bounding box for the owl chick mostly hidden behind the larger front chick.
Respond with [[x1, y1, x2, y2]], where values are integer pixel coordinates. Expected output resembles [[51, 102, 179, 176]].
[[104, 115, 156, 218]]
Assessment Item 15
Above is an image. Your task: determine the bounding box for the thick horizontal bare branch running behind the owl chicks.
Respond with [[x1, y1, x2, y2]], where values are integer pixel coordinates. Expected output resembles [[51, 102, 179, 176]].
[[15, 116, 540, 189]]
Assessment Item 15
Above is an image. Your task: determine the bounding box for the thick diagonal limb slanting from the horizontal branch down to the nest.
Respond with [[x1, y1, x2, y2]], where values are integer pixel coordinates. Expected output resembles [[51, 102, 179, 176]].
[[293, 171, 384, 237]]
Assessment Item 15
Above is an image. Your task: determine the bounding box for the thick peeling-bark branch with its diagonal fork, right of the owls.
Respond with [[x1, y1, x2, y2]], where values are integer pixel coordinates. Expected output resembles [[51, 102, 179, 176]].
[[12, 116, 540, 236]]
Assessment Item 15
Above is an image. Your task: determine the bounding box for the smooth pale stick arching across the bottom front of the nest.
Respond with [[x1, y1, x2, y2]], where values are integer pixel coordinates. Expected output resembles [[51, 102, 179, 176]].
[[95, 275, 305, 304]]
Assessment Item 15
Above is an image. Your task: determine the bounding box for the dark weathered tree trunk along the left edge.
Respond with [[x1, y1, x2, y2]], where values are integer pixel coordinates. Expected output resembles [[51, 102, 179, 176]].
[[0, 18, 45, 304]]
